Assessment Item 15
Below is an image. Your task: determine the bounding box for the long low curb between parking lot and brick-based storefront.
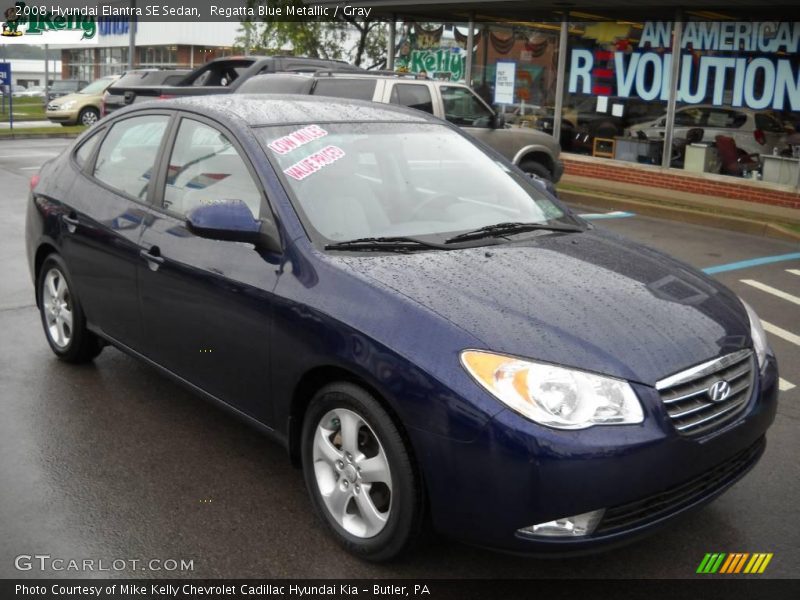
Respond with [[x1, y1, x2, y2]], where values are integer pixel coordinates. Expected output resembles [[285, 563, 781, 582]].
[[558, 190, 800, 242]]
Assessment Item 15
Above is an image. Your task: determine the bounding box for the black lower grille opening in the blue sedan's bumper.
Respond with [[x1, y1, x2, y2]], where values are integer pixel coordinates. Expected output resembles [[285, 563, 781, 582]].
[[595, 437, 766, 535]]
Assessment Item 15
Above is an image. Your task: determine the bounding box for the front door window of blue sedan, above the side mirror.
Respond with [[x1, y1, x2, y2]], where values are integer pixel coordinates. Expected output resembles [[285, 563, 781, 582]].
[[163, 119, 261, 218]]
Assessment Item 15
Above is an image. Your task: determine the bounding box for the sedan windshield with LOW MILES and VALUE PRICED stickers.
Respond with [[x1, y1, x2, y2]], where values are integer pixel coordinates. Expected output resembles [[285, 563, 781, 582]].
[[257, 123, 575, 242]]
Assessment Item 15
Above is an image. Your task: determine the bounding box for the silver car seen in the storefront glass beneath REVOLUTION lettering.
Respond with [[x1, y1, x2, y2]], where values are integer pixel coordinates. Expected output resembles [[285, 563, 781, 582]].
[[630, 104, 786, 154]]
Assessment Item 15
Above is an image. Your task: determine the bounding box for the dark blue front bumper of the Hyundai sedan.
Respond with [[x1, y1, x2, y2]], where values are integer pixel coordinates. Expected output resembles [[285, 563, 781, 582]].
[[415, 358, 778, 554]]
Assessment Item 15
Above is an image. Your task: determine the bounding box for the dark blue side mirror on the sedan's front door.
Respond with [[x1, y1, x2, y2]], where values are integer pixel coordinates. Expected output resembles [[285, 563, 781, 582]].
[[186, 200, 281, 252]]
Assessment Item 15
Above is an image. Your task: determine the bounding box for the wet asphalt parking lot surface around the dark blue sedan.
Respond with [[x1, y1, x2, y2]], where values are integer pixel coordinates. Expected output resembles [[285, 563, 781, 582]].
[[0, 139, 800, 578]]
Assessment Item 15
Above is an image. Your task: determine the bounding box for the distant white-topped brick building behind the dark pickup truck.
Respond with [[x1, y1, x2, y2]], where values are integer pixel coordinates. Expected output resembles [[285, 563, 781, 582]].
[[52, 18, 241, 81]]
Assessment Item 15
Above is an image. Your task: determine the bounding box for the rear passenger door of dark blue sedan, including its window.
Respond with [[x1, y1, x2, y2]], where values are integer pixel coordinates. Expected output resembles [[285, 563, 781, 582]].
[[62, 112, 171, 350]]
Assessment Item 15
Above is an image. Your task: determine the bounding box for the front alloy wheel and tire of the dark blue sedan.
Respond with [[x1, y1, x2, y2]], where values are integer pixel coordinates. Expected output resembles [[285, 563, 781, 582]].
[[302, 383, 423, 561]]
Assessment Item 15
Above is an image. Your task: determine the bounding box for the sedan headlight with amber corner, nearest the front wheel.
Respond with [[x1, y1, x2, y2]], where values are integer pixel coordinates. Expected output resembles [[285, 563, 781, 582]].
[[461, 350, 644, 429]]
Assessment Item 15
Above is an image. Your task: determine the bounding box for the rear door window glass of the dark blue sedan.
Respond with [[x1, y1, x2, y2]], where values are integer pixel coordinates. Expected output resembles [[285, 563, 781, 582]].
[[94, 115, 169, 200]]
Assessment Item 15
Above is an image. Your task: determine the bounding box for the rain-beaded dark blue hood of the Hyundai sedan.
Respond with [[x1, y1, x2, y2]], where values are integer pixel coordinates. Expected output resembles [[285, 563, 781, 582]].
[[335, 231, 750, 385]]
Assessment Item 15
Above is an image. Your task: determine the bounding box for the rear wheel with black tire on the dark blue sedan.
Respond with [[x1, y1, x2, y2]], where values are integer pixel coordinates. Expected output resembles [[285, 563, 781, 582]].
[[36, 254, 103, 363]]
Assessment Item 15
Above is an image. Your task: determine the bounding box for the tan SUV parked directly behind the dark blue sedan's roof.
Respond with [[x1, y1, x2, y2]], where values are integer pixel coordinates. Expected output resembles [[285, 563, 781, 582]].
[[236, 72, 564, 183]]
